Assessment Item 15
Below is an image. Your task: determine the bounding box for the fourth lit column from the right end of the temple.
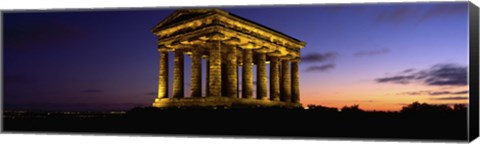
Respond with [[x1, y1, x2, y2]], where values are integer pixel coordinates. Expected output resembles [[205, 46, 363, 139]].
[[257, 53, 268, 100]]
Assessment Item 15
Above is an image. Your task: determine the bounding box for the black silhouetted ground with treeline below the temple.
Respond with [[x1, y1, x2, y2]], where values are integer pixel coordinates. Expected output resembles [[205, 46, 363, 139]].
[[3, 108, 467, 141]]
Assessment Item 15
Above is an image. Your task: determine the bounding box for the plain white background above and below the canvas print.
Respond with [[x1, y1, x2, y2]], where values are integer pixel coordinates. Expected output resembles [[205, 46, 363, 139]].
[[0, 0, 480, 144]]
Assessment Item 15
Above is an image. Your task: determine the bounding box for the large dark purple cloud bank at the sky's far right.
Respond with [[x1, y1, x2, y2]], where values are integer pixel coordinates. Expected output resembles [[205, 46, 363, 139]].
[[376, 64, 467, 86]]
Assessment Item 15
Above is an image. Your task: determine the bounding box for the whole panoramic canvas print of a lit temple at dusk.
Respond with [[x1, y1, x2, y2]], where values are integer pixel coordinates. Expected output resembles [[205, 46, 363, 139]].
[[2, 2, 478, 141]]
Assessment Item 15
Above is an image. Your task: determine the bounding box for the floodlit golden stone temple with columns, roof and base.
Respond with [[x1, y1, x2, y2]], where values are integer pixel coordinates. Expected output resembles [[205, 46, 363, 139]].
[[152, 9, 305, 107]]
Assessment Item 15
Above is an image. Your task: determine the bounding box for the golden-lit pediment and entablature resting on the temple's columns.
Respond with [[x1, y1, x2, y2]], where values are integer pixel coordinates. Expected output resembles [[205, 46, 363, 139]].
[[152, 9, 305, 57]]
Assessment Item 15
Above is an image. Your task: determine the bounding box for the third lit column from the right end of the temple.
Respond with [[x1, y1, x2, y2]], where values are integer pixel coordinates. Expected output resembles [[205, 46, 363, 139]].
[[270, 57, 280, 101]]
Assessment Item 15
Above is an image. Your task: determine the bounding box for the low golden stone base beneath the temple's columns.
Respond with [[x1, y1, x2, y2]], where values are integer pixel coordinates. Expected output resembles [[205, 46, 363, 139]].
[[153, 97, 302, 108]]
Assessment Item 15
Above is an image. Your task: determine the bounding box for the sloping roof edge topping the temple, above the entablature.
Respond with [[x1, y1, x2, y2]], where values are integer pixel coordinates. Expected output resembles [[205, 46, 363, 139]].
[[152, 9, 305, 45]]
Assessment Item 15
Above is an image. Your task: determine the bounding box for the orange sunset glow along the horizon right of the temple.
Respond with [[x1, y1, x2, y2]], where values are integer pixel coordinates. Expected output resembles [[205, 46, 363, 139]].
[[300, 80, 468, 111]]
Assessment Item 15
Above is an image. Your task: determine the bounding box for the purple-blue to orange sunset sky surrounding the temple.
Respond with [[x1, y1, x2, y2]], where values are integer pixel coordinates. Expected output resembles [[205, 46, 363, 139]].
[[2, 2, 469, 111]]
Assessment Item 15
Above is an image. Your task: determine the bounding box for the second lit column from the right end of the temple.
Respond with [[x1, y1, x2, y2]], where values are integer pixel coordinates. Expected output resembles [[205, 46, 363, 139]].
[[280, 60, 292, 102]]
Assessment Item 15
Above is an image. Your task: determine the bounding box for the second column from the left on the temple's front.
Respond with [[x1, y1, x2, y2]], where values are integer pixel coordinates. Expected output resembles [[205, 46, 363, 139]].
[[173, 50, 184, 98]]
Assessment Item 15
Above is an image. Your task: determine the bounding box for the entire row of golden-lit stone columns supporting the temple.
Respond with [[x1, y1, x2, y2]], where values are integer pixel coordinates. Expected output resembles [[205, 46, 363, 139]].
[[158, 43, 300, 103]]
